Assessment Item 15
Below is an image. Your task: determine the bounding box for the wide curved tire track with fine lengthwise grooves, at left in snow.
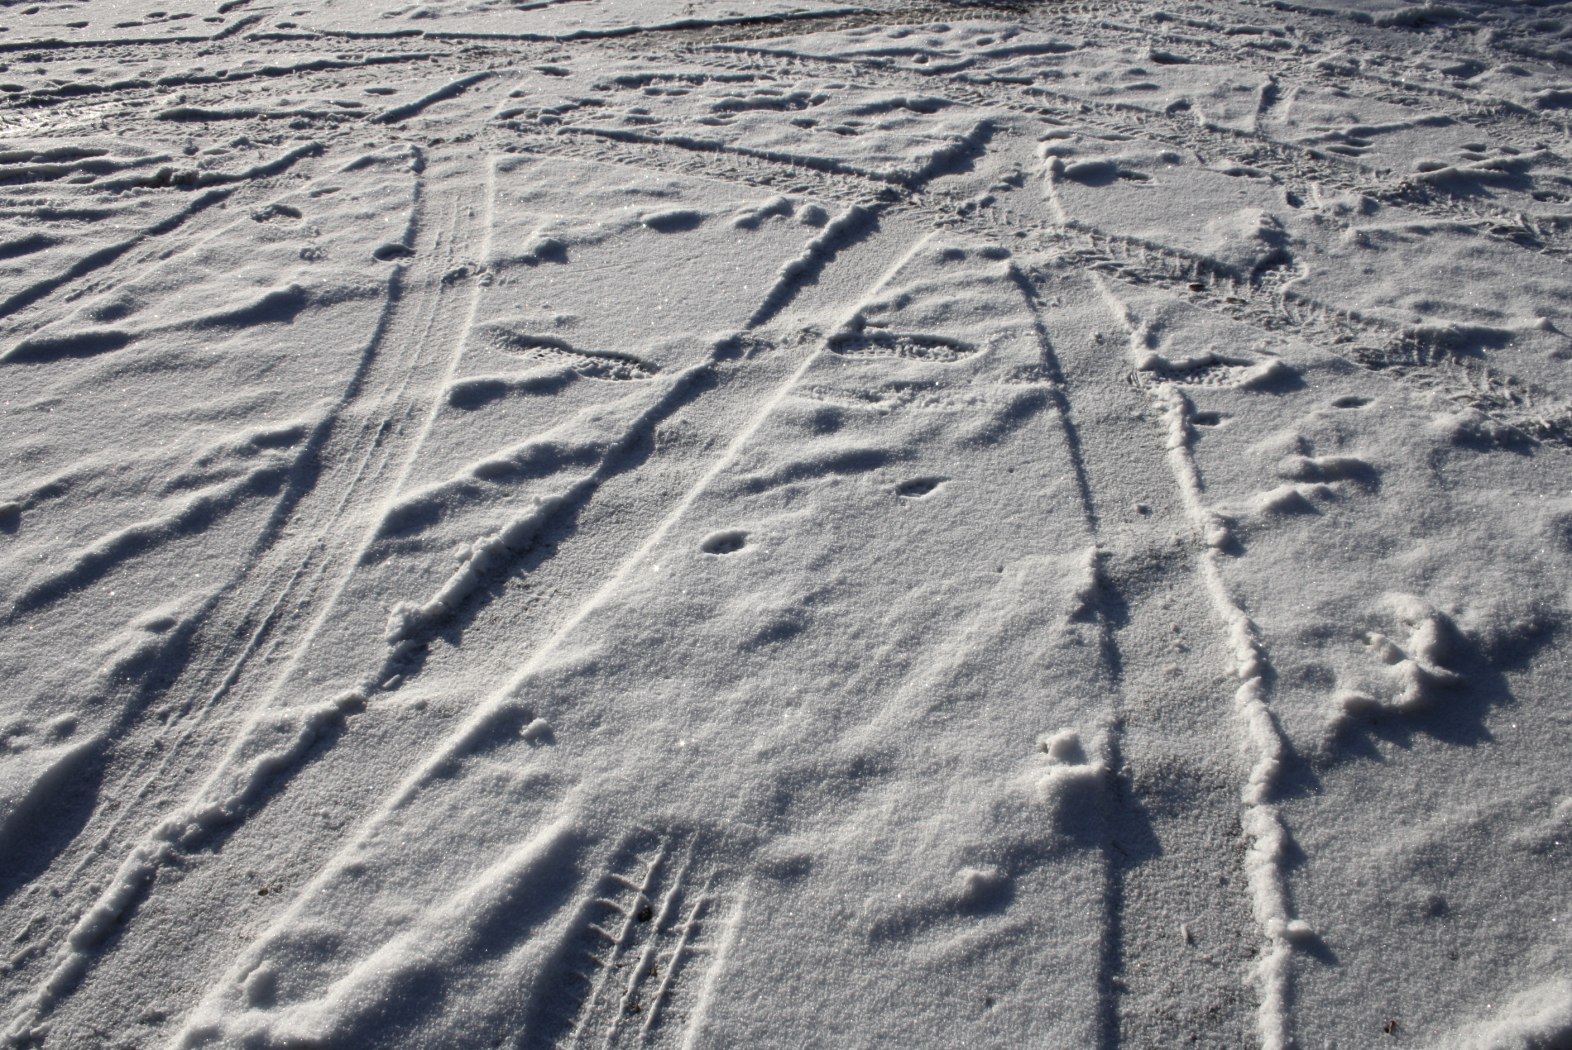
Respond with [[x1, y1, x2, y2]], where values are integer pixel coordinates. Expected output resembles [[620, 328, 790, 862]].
[[0, 143, 490, 1033]]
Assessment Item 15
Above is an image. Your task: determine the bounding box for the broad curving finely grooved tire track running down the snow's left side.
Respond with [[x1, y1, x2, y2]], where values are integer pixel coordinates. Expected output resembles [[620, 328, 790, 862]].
[[0, 141, 496, 1033]]
